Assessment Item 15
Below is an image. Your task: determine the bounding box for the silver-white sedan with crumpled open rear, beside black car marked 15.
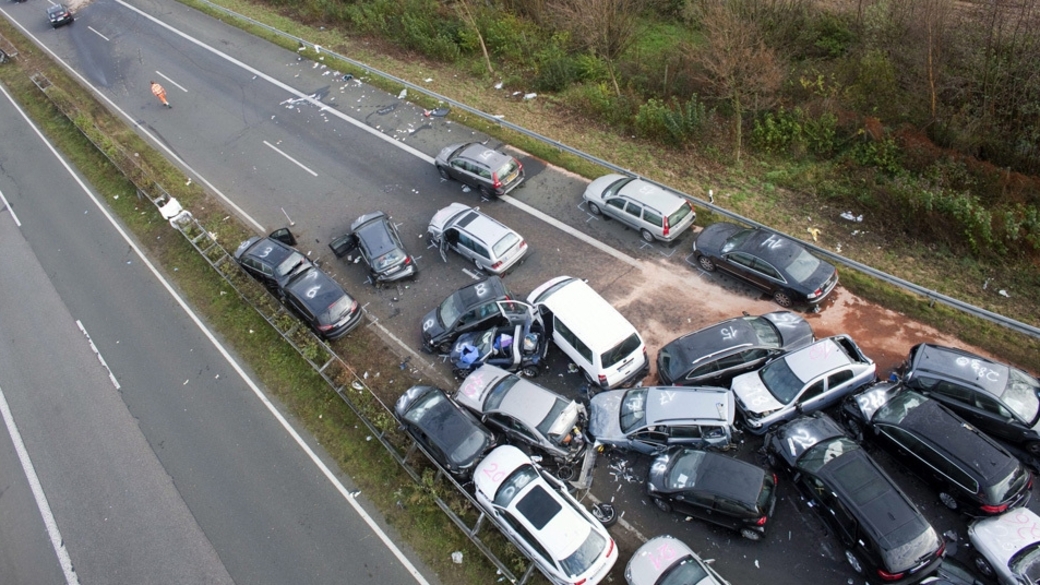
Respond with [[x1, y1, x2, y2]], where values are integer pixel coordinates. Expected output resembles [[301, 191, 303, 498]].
[[731, 335, 876, 435]]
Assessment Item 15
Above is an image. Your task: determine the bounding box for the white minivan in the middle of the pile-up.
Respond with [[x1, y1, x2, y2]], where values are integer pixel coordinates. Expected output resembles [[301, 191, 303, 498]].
[[527, 276, 650, 388]]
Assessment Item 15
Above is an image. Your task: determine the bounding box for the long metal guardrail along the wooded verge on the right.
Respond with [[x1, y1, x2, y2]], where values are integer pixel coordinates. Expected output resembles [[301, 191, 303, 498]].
[[200, 0, 1040, 338]]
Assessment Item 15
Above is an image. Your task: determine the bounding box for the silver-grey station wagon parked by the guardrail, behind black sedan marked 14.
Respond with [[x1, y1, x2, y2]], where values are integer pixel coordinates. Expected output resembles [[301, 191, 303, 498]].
[[582, 174, 697, 243]]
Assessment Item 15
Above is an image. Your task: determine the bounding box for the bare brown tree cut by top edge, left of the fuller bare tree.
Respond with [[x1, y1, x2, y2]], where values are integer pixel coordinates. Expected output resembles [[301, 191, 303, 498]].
[[549, 0, 643, 96]]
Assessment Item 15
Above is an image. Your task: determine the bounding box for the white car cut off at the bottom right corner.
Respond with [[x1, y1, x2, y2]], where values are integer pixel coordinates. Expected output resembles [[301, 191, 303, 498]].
[[968, 507, 1040, 585]]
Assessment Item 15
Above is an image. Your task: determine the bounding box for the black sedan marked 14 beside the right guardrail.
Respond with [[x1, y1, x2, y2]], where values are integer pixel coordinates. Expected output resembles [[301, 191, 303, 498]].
[[694, 222, 838, 307]]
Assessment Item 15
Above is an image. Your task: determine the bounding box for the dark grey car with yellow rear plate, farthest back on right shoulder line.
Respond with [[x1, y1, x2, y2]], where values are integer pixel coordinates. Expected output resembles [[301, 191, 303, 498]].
[[434, 143, 524, 199]]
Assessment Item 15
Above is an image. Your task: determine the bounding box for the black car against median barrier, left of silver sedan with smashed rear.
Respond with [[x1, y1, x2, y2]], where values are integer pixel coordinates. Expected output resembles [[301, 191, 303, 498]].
[[394, 386, 495, 480]]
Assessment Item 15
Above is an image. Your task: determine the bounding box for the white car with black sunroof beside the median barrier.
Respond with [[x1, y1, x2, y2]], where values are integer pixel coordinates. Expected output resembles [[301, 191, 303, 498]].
[[473, 444, 618, 585]]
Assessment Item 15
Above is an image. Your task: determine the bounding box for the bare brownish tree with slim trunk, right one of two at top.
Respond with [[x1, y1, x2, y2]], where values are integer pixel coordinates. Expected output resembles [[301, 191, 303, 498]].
[[691, 0, 784, 160]]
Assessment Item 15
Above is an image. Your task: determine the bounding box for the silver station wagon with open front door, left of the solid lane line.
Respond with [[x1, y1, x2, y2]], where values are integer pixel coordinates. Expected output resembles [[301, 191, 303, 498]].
[[426, 203, 527, 275]]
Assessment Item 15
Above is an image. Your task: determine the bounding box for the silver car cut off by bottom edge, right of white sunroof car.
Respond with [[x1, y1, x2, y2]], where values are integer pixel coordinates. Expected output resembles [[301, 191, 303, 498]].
[[625, 535, 729, 585]]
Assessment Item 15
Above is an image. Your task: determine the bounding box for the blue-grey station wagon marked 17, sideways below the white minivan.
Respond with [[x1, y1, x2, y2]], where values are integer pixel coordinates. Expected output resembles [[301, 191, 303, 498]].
[[589, 386, 736, 454]]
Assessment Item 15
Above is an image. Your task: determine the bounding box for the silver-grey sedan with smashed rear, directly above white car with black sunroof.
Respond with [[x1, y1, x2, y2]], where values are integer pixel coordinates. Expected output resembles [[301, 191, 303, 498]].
[[454, 365, 587, 465]]
